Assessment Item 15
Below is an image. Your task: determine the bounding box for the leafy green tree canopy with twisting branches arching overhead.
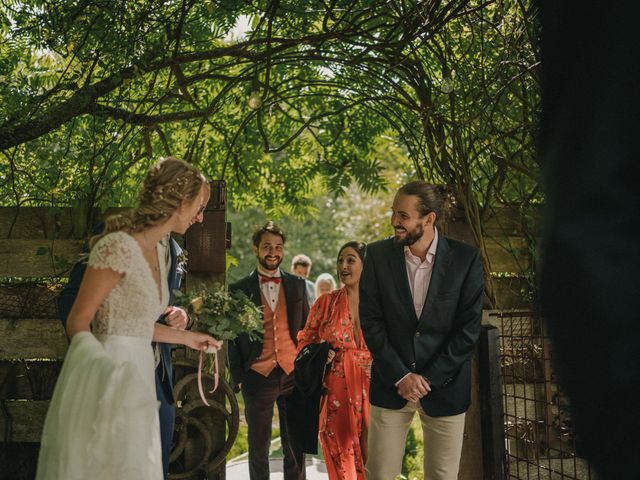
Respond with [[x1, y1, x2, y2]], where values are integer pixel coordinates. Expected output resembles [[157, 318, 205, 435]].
[[0, 0, 535, 214]]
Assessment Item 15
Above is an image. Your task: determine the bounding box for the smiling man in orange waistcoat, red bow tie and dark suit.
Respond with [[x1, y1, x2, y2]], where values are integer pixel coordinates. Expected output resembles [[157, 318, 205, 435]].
[[228, 222, 309, 480]]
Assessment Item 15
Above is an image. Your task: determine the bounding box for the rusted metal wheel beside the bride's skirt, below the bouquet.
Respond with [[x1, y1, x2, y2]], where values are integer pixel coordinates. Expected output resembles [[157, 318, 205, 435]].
[[169, 359, 240, 480]]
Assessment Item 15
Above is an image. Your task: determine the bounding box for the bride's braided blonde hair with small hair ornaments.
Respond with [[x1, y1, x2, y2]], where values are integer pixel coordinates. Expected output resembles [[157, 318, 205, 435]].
[[89, 157, 206, 247]]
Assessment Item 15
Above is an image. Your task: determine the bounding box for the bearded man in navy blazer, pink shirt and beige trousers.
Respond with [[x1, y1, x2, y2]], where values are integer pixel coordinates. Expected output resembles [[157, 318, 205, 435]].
[[360, 181, 484, 480]]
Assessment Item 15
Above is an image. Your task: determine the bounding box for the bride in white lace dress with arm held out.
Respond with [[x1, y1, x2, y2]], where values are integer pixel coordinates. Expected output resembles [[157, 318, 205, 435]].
[[36, 158, 221, 480]]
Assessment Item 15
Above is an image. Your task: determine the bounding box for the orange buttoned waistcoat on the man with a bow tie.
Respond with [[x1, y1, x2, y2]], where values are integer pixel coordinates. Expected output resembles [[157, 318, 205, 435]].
[[251, 285, 296, 377]]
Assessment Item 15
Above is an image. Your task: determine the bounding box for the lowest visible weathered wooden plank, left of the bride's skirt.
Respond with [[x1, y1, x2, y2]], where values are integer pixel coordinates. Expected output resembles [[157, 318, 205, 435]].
[[0, 400, 49, 443]]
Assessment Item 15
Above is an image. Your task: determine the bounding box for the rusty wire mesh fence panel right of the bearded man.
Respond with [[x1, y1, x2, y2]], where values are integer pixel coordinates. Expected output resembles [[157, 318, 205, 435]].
[[490, 312, 596, 480]]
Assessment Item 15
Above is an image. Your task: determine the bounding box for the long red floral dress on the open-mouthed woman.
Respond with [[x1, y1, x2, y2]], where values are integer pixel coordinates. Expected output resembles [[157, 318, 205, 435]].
[[298, 288, 371, 480]]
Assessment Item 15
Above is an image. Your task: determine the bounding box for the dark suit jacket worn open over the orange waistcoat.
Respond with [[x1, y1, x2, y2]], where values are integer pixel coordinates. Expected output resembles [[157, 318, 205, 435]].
[[227, 270, 309, 385]]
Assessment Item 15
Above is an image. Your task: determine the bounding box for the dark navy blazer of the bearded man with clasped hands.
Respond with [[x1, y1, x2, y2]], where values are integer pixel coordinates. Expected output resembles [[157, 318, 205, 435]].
[[360, 232, 484, 417]]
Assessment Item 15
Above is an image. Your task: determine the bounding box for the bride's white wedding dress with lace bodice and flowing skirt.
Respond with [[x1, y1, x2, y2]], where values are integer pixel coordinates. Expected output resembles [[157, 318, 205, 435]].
[[36, 232, 169, 480]]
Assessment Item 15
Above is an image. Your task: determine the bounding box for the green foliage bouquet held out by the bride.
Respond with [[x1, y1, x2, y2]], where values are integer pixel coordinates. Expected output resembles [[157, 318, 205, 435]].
[[176, 285, 264, 340]]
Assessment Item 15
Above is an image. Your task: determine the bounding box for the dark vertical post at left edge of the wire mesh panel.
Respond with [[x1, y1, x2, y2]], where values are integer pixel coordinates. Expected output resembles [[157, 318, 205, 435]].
[[479, 325, 505, 480]]
